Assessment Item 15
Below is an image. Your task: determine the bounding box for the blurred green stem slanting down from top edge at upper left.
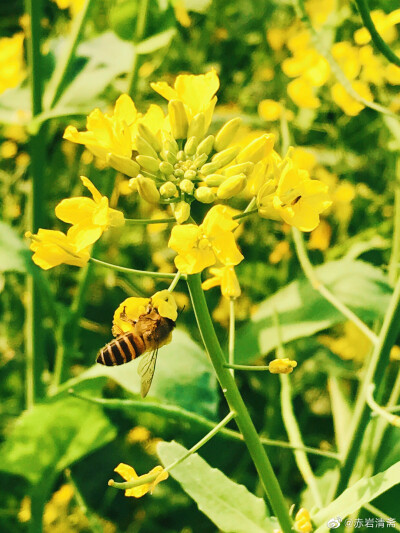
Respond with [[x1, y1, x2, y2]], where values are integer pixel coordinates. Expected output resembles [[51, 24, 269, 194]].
[[45, 0, 94, 109]]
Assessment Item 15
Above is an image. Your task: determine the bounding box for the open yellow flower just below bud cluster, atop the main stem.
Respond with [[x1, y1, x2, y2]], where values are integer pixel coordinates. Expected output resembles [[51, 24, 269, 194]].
[[168, 205, 243, 274]]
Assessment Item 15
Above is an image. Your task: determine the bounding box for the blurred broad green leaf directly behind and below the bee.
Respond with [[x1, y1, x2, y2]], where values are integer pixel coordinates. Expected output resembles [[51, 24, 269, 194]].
[[59, 330, 218, 420]]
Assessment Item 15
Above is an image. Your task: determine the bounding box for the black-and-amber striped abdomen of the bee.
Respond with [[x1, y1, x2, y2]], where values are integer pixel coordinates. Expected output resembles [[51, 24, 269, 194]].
[[97, 332, 144, 366]]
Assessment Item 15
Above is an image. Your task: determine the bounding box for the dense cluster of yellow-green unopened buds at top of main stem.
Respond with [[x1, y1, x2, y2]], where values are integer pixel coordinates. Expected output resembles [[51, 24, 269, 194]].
[[130, 111, 273, 223]]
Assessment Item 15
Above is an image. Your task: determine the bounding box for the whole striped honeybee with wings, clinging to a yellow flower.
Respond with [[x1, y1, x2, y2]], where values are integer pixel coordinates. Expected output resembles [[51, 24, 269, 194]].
[[96, 303, 175, 398]]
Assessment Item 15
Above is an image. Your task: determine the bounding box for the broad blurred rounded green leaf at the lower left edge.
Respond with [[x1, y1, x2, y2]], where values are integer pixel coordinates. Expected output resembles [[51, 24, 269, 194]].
[[0, 398, 116, 484]]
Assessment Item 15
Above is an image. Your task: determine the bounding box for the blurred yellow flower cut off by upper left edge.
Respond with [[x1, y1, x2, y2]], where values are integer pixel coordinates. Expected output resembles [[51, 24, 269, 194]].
[[0, 33, 25, 94]]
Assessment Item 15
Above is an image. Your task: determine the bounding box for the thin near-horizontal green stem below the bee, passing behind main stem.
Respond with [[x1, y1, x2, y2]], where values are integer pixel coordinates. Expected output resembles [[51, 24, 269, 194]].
[[69, 389, 340, 461]]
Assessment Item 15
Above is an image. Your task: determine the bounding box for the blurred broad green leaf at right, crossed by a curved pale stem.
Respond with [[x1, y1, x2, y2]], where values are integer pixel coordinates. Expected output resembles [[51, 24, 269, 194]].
[[236, 260, 392, 363]]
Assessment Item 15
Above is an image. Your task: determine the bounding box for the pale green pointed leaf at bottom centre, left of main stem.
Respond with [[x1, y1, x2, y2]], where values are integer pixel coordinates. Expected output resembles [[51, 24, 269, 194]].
[[157, 442, 272, 533]]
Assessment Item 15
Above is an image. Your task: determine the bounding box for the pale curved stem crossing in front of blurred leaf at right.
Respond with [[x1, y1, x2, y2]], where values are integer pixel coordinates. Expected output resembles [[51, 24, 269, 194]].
[[292, 227, 378, 345]]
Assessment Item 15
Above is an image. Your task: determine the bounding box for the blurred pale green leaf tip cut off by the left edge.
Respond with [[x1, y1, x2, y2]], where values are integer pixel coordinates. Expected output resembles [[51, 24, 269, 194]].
[[0, 222, 33, 272]]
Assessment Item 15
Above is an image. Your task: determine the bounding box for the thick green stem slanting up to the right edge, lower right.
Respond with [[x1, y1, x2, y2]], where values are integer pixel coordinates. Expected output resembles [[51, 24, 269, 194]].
[[336, 272, 400, 496]]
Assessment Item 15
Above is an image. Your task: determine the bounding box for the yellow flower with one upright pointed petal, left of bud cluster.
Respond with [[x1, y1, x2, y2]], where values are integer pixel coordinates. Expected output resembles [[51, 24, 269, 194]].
[[56, 176, 125, 250]]
